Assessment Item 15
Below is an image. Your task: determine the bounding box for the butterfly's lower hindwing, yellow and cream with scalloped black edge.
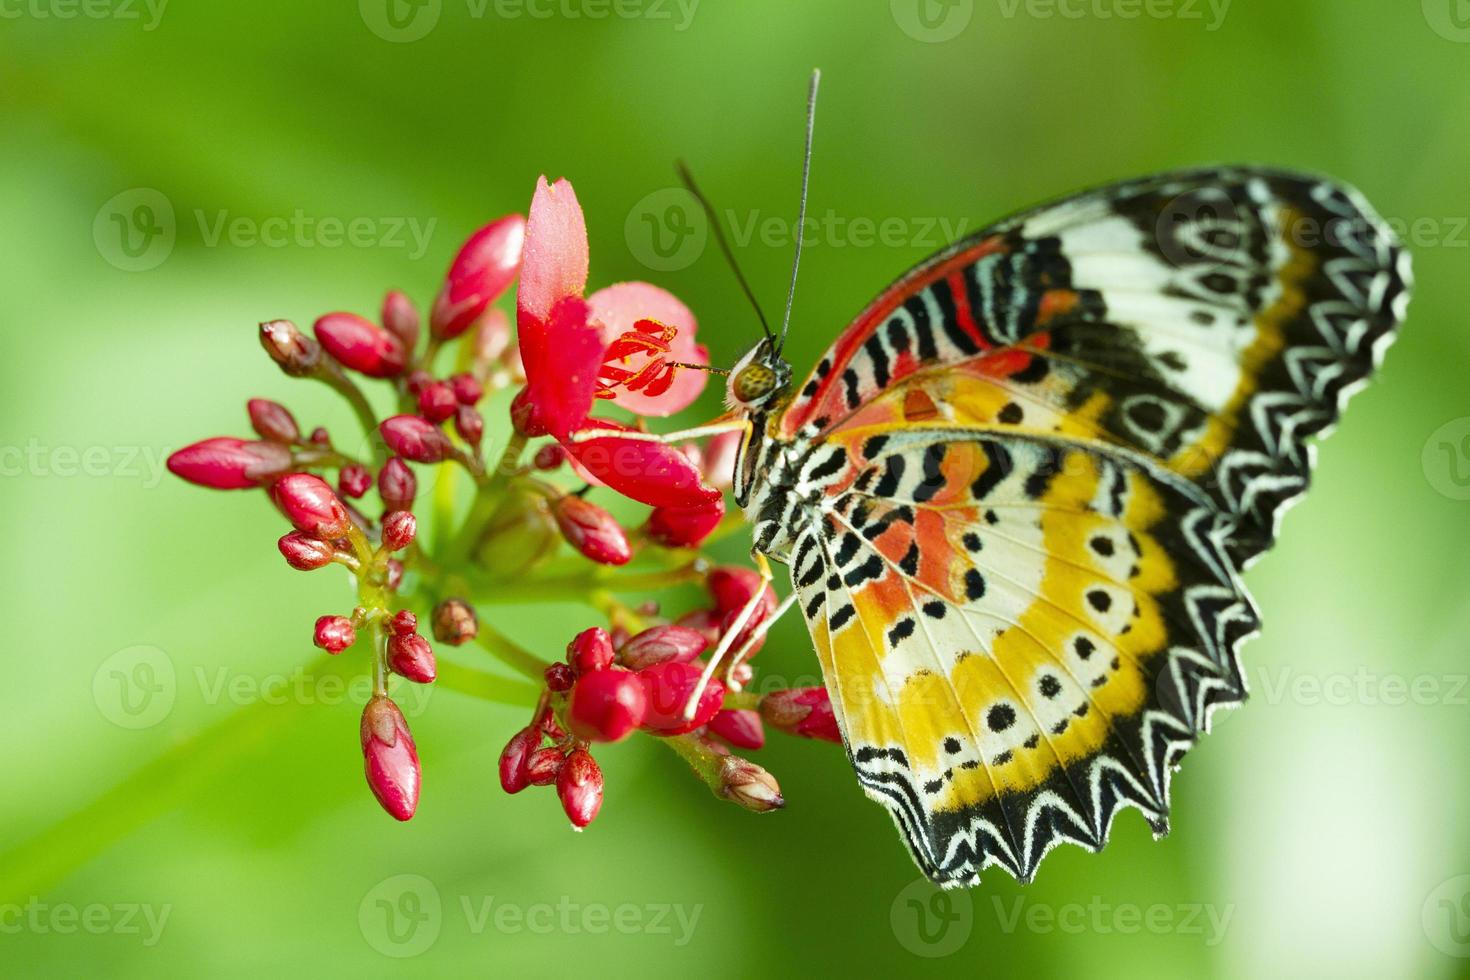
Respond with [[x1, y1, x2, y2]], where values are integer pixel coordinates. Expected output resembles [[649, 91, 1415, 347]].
[[792, 428, 1257, 884]]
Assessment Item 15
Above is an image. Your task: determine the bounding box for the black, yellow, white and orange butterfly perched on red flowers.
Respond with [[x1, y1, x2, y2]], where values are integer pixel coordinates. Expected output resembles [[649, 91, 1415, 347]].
[[699, 89, 1411, 886]]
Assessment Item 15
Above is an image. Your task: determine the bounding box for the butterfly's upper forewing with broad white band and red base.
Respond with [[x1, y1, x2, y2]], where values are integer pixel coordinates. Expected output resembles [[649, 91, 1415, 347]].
[[781, 169, 1410, 566]]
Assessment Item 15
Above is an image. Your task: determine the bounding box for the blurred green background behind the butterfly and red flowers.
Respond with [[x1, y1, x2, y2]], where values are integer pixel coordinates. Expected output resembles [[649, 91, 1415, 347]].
[[0, 0, 1470, 977]]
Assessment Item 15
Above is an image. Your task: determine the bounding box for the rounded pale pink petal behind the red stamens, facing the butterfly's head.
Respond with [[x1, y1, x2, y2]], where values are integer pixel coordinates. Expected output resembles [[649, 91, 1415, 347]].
[[587, 282, 710, 417]]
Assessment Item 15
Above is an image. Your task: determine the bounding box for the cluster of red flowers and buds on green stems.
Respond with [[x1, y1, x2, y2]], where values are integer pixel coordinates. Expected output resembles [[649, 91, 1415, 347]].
[[169, 178, 839, 852]]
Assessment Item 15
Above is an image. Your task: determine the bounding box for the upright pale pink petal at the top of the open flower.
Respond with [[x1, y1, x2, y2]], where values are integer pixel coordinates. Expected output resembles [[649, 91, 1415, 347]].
[[516, 176, 587, 322]]
